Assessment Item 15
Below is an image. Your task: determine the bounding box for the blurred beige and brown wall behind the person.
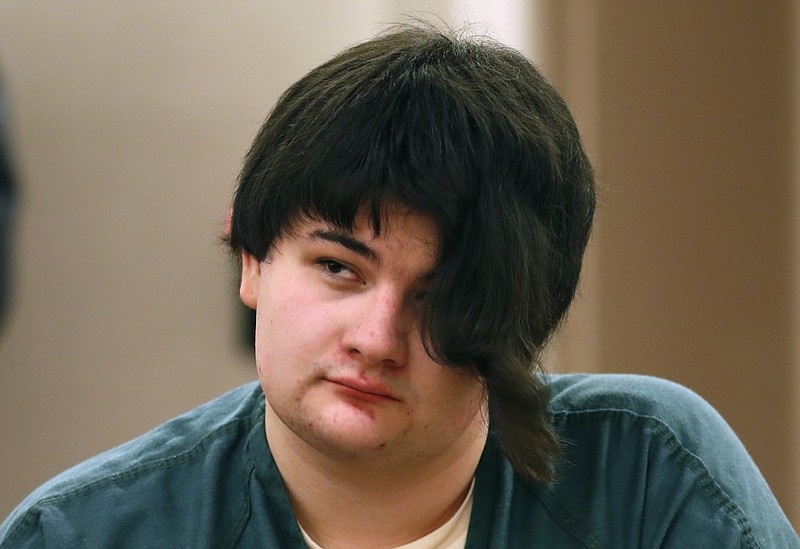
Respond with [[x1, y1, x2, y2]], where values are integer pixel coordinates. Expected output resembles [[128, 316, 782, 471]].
[[0, 0, 800, 526]]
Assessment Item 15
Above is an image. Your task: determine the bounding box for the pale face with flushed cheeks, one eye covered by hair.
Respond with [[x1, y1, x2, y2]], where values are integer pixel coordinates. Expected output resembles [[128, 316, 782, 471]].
[[240, 208, 486, 465]]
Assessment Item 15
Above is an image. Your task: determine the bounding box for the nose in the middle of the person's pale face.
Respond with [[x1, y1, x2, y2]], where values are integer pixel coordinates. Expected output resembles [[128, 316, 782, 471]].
[[343, 290, 413, 366]]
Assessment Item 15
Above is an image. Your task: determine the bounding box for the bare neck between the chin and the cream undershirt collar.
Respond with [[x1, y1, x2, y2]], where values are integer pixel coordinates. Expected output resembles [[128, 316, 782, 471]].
[[266, 404, 488, 548]]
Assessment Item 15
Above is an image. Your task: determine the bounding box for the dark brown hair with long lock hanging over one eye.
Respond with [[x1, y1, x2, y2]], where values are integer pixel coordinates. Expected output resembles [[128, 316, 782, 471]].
[[229, 26, 595, 482]]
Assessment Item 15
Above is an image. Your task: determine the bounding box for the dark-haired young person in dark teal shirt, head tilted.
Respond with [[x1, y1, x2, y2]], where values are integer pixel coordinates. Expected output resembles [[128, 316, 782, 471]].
[[0, 26, 800, 548]]
